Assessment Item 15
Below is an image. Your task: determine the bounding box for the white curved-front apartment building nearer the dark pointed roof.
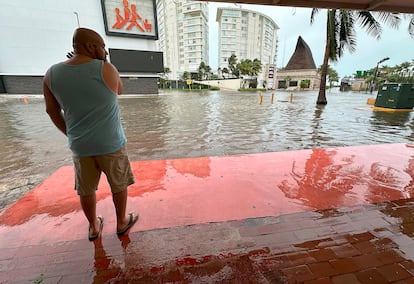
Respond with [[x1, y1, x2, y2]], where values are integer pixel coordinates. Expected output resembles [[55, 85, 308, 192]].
[[216, 8, 279, 68]]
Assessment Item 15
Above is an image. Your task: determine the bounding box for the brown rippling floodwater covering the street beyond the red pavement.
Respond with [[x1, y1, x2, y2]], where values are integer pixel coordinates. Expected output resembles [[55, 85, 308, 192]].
[[0, 90, 414, 200]]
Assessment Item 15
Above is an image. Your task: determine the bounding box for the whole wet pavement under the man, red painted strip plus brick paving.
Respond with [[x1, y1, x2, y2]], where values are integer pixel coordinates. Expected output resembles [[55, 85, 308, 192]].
[[0, 144, 414, 283]]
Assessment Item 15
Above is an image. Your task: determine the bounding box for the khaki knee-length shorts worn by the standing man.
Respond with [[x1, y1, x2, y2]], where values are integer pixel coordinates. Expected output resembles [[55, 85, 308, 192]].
[[73, 147, 135, 196]]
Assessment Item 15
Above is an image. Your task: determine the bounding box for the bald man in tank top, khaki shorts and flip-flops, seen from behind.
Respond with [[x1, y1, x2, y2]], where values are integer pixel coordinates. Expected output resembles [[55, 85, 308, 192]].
[[43, 28, 138, 241]]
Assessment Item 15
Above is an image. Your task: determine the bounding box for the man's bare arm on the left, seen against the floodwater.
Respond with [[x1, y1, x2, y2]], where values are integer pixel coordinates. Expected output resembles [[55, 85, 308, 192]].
[[43, 71, 66, 135]]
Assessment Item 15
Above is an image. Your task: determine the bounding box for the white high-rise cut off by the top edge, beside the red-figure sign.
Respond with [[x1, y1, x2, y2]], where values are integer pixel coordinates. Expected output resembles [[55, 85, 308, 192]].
[[156, 0, 209, 80]]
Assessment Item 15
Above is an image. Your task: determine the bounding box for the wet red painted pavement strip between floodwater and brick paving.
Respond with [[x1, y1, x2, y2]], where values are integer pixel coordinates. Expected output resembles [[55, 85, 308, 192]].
[[0, 144, 414, 248]]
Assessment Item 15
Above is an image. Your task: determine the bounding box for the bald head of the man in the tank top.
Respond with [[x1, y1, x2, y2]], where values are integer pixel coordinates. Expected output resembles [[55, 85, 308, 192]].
[[73, 28, 107, 60]]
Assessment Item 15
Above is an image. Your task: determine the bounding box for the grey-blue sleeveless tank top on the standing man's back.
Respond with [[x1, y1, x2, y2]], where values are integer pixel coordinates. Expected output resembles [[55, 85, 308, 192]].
[[50, 60, 126, 157]]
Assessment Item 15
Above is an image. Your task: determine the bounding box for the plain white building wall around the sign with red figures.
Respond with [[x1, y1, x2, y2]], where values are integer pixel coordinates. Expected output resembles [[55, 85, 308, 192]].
[[0, 0, 156, 75]]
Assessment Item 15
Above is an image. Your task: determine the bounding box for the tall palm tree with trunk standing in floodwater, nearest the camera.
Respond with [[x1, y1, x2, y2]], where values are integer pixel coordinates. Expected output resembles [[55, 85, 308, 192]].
[[310, 8, 401, 105]]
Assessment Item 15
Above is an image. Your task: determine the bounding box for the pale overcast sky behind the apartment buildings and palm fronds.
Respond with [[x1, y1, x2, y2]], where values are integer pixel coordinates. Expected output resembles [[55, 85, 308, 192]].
[[209, 2, 414, 78]]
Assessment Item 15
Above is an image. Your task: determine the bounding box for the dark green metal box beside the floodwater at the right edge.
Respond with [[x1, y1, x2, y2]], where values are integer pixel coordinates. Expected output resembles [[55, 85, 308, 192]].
[[374, 83, 414, 109]]
